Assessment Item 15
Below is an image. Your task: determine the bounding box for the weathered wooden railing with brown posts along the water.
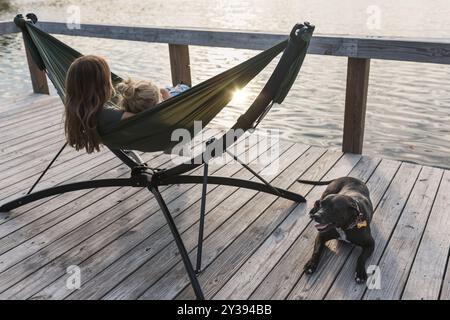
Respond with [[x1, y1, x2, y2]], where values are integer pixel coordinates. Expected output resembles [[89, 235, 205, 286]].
[[0, 22, 450, 153]]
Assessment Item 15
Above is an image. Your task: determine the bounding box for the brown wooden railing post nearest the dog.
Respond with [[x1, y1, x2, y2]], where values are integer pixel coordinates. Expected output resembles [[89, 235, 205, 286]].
[[342, 58, 370, 154]]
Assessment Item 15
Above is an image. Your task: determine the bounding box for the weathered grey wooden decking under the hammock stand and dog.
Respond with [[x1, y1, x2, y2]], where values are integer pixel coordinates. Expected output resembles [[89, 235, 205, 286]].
[[0, 95, 450, 299]]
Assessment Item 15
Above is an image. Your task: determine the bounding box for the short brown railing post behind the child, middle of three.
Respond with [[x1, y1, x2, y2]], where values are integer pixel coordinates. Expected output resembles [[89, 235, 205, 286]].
[[169, 43, 192, 86]]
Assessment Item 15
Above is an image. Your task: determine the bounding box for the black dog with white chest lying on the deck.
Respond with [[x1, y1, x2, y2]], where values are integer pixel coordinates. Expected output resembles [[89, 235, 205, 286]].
[[298, 177, 375, 284]]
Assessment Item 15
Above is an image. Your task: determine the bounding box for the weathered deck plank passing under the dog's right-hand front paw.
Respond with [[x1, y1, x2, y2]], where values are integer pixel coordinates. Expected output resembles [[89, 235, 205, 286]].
[[325, 163, 426, 300]]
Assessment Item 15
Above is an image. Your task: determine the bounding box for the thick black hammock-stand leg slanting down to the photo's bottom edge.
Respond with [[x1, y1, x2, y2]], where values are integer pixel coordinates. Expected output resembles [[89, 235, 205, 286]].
[[149, 186, 205, 300]]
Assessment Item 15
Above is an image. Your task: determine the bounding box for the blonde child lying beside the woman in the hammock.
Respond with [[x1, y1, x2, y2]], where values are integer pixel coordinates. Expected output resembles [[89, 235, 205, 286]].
[[116, 79, 189, 113]]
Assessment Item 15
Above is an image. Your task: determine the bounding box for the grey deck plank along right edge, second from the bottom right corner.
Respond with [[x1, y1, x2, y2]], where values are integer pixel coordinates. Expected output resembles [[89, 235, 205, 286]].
[[402, 170, 450, 300]]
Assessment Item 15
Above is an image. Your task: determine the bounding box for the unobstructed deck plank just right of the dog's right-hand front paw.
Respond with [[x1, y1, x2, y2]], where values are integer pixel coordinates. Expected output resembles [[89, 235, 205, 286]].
[[364, 167, 443, 300]]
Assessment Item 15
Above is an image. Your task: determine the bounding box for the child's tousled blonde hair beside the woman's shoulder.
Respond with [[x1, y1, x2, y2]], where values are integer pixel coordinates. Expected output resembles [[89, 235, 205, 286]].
[[116, 79, 161, 113]]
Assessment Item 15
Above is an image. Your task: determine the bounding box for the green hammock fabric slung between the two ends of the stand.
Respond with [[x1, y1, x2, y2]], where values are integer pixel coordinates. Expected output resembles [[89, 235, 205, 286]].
[[14, 15, 313, 152]]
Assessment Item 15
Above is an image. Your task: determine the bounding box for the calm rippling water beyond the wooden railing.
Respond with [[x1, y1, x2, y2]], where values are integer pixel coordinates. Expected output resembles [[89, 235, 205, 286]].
[[0, 0, 450, 167]]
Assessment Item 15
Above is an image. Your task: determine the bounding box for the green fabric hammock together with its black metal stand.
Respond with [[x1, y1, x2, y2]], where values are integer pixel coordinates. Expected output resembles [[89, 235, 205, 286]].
[[0, 14, 314, 299]]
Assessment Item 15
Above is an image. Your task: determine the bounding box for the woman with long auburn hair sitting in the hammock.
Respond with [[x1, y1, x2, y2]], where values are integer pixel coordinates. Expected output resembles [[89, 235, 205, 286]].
[[64, 55, 133, 153]]
